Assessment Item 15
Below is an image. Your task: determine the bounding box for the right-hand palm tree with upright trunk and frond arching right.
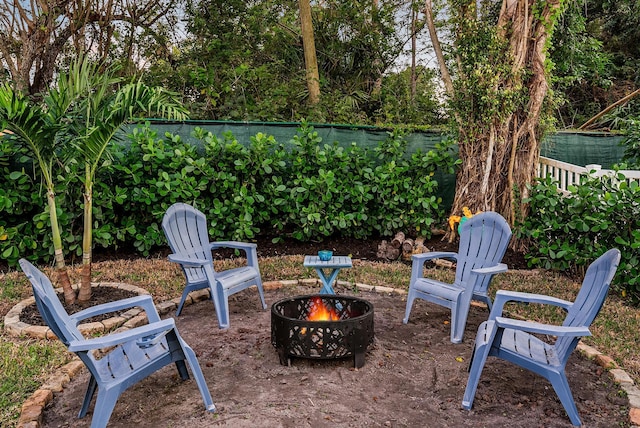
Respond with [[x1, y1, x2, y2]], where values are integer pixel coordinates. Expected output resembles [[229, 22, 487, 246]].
[[59, 58, 187, 303]]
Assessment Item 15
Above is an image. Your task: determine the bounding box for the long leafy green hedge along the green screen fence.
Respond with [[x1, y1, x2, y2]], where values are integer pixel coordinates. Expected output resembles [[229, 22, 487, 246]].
[[0, 124, 456, 265]]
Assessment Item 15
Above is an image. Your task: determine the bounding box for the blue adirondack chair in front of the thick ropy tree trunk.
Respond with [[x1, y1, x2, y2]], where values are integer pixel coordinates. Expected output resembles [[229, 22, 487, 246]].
[[402, 211, 511, 343]]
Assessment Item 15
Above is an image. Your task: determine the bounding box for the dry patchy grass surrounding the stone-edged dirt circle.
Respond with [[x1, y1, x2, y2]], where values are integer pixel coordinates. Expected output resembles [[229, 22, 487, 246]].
[[0, 256, 640, 427]]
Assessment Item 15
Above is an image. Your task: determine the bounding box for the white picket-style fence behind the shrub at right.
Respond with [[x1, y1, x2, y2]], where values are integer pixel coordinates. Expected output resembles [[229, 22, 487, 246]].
[[538, 156, 640, 194]]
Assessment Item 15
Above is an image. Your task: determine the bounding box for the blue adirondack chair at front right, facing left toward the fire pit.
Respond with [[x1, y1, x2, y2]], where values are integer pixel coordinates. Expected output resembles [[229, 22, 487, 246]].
[[462, 249, 620, 425]]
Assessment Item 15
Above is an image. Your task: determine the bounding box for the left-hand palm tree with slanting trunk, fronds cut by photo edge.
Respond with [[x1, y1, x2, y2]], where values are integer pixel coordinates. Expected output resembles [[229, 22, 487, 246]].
[[0, 83, 75, 304]]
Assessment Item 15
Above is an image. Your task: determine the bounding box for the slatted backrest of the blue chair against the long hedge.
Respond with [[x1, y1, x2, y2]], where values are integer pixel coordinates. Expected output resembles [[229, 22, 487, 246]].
[[162, 203, 215, 283]]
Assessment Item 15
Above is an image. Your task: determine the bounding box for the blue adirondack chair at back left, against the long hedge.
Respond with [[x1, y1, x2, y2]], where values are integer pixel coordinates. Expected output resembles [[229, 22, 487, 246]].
[[162, 203, 267, 328]]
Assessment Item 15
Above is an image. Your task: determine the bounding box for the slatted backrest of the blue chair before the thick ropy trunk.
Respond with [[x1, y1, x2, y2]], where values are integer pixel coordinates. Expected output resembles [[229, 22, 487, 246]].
[[455, 212, 511, 293]]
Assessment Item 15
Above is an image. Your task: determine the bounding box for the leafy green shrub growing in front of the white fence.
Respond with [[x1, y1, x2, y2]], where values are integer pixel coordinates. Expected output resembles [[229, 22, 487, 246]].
[[517, 170, 640, 301]]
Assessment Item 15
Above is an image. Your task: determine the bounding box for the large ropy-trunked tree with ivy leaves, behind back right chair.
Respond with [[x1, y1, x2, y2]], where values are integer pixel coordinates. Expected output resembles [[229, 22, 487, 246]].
[[425, 0, 564, 231]]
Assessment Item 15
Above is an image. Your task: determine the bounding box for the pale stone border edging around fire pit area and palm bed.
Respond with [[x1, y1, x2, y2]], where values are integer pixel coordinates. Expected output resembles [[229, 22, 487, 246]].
[[11, 279, 640, 428]]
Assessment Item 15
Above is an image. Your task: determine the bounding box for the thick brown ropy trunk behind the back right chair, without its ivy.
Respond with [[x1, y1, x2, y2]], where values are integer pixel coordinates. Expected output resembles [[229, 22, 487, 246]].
[[442, 0, 560, 232]]
